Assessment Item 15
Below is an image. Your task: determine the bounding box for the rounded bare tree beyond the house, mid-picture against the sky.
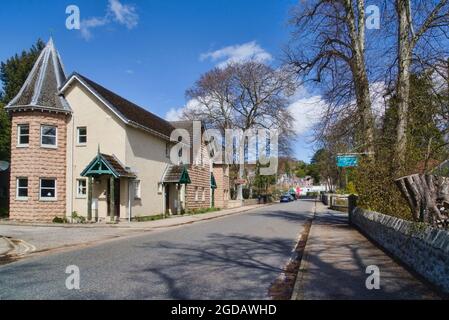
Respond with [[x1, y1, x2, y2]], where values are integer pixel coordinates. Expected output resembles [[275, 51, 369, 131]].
[[184, 61, 296, 199]]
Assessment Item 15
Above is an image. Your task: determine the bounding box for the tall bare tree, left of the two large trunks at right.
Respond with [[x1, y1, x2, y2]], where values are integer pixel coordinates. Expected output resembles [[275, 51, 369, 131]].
[[287, 0, 374, 153]]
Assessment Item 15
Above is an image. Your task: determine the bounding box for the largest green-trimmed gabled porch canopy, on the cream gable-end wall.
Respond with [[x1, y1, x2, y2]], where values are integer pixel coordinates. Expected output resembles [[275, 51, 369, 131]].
[[81, 153, 136, 179]]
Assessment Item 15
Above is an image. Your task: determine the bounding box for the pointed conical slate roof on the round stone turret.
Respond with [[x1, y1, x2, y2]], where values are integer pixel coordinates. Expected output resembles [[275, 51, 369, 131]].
[[6, 39, 71, 112]]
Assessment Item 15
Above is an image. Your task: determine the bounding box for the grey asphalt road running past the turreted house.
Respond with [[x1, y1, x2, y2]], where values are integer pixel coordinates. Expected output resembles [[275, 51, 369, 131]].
[[0, 201, 314, 300]]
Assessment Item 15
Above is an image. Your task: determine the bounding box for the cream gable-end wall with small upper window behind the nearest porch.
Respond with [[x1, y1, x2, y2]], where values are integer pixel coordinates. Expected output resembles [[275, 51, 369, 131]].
[[65, 82, 128, 218]]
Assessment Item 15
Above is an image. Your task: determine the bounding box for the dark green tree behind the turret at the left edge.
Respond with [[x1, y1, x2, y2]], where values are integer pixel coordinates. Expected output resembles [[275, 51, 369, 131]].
[[0, 39, 45, 160]]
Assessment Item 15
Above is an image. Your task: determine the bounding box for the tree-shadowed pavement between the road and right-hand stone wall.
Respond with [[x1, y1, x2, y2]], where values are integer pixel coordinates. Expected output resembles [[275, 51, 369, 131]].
[[292, 204, 439, 300]]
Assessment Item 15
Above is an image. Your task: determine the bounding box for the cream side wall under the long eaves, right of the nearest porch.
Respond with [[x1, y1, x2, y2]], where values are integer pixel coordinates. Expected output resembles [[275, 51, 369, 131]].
[[126, 127, 170, 217]]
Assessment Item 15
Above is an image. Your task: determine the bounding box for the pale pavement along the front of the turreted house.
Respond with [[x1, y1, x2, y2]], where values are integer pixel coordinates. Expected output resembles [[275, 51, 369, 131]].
[[0, 205, 265, 257]]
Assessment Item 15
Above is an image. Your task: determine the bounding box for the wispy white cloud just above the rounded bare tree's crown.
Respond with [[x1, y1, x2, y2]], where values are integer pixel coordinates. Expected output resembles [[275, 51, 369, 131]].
[[200, 41, 273, 68]]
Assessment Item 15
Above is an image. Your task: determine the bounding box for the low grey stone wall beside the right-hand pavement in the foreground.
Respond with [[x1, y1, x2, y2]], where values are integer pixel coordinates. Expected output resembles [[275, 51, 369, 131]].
[[350, 208, 449, 294]]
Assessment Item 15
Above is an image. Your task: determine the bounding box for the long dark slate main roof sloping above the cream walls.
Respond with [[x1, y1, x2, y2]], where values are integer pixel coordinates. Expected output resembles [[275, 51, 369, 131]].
[[63, 73, 175, 138]]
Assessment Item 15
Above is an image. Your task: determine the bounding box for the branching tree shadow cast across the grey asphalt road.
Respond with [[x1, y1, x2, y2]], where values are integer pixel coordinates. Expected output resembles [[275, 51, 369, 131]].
[[130, 233, 294, 299]]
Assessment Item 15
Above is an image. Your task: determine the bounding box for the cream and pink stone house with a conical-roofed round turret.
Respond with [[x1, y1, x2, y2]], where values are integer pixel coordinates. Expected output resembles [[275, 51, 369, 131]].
[[6, 39, 229, 222]]
